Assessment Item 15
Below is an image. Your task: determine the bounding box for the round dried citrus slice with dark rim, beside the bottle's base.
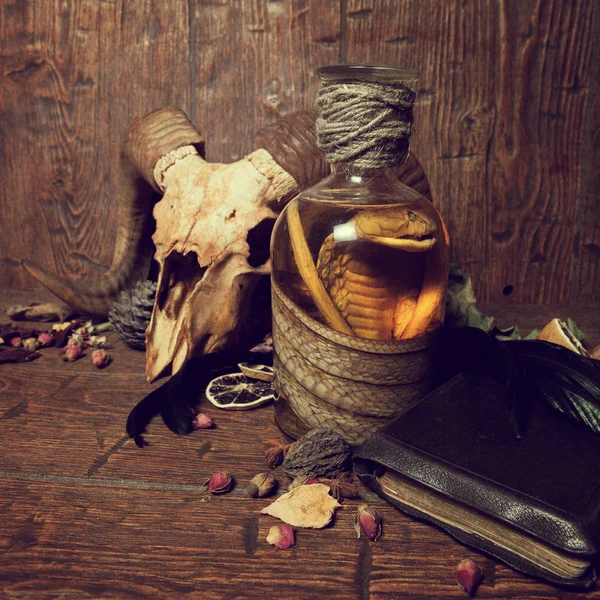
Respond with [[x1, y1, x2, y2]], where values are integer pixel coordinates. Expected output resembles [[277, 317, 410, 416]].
[[206, 373, 275, 410]]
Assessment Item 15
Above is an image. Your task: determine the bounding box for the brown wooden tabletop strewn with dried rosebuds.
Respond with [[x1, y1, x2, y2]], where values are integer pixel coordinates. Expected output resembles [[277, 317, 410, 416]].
[[0, 291, 600, 600]]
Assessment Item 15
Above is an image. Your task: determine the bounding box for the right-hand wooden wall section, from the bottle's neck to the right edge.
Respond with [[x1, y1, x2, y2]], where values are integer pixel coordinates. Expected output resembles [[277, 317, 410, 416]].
[[343, 0, 600, 303]]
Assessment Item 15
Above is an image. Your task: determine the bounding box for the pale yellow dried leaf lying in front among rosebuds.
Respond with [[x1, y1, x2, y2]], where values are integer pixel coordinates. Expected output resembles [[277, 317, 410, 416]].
[[260, 483, 341, 529]]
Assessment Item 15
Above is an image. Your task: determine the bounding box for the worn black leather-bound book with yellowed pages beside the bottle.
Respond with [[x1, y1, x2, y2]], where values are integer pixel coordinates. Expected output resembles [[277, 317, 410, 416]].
[[353, 374, 600, 587]]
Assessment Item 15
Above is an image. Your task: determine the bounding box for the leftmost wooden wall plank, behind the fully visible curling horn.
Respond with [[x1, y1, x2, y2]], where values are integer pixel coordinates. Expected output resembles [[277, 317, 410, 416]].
[[0, 0, 190, 287]]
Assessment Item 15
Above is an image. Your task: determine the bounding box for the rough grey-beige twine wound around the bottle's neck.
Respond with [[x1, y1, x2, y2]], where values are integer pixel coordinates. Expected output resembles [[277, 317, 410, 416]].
[[317, 79, 416, 169]]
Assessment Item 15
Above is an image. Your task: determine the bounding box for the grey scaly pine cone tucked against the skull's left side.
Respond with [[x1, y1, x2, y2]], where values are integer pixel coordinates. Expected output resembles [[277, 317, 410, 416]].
[[108, 281, 156, 350]]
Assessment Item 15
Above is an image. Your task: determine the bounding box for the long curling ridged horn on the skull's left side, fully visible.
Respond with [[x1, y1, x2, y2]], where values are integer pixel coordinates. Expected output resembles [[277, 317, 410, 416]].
[[22, 107, 203, 316]]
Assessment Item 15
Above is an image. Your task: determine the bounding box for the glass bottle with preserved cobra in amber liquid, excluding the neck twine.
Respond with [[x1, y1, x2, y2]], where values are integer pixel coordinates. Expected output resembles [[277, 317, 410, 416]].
[[271, 65, 448, 444]]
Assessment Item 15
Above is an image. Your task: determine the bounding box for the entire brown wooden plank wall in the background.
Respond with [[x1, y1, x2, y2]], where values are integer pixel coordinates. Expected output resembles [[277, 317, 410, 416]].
[[0, 0, 600, 305]]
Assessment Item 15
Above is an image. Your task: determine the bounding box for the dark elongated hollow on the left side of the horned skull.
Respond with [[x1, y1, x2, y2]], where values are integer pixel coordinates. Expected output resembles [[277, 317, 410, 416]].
[[156, 251, 206, 319]]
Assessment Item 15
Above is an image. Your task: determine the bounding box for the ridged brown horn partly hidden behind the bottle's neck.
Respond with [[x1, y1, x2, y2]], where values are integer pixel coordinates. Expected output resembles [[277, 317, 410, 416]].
[[256, 110, 431, 200]]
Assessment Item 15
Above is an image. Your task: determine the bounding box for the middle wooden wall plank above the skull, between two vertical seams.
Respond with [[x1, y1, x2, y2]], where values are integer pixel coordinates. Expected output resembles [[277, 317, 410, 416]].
[[192, 0, 340, 162]]
